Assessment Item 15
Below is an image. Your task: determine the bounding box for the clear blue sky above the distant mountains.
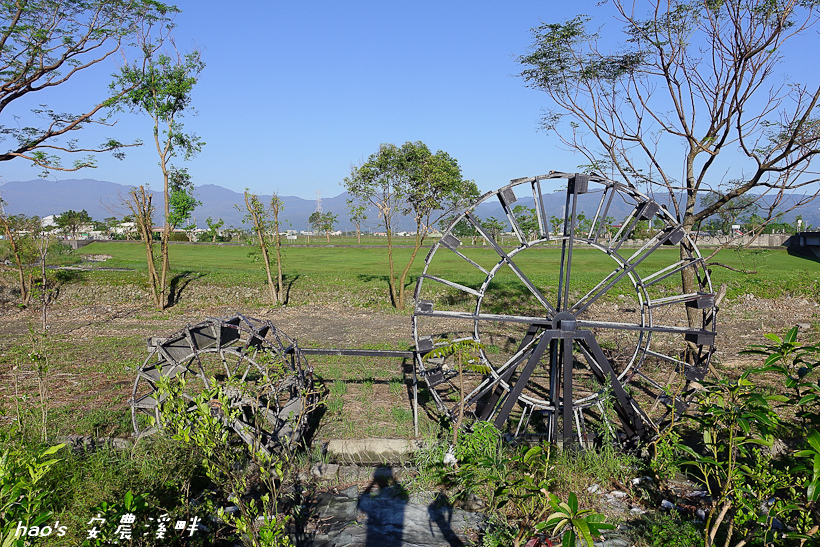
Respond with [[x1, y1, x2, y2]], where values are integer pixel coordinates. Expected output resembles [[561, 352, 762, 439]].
[[0, 0, 817, 203]]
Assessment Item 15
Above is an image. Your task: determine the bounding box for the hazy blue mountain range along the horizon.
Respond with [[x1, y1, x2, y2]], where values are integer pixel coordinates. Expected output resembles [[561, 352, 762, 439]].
[[0, 179, 820, 231]]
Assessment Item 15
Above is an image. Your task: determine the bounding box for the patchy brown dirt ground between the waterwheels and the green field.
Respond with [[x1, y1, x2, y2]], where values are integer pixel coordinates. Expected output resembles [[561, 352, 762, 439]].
[[0, 274, 820, 437]]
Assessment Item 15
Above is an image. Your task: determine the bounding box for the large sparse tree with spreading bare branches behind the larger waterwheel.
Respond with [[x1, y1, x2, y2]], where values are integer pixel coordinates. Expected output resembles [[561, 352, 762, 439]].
[[519, 0, 820, 300]]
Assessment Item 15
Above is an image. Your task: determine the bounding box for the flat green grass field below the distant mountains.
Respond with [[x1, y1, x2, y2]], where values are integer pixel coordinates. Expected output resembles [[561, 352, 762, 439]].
[[80, 242, 820, 299]]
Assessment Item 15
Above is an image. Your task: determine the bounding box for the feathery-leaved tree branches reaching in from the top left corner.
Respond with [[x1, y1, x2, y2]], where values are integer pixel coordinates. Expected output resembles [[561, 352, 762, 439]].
[[0, 0, 178, 172]]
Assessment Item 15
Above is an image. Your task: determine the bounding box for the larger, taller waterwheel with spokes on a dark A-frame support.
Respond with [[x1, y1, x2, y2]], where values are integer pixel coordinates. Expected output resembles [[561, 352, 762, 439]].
[[412, 172, 716, 446]]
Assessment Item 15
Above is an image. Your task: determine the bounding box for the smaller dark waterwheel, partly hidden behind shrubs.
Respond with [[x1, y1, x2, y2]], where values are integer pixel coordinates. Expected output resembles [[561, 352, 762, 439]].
[[130, 315, 316, 453]]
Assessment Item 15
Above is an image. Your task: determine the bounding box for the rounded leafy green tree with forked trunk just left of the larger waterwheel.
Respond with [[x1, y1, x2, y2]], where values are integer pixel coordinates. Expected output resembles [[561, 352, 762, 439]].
[[344, 142, 478, 309]]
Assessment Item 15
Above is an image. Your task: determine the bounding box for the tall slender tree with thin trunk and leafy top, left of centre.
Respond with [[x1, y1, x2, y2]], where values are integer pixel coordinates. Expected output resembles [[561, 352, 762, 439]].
[[112, 51, 205, 310]]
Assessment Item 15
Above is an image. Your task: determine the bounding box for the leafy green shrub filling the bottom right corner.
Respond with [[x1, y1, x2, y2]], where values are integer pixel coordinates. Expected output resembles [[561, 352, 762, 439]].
[[678, 328, 820, 547]]
